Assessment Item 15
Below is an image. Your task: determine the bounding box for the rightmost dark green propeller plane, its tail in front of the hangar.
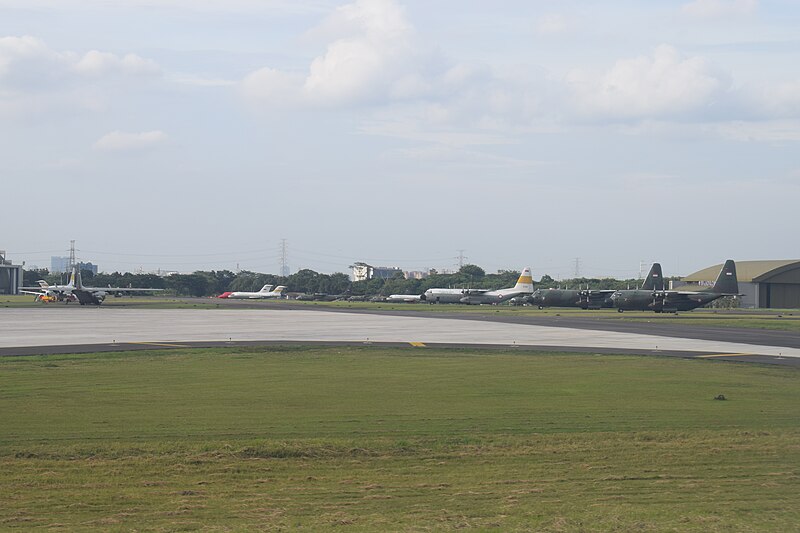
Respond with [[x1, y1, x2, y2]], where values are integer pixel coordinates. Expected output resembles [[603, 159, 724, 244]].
[[611, 259, 739, 313]]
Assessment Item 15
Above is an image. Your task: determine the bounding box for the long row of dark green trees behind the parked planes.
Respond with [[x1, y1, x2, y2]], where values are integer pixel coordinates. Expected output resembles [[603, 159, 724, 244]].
[[23, 265, 668, 296]]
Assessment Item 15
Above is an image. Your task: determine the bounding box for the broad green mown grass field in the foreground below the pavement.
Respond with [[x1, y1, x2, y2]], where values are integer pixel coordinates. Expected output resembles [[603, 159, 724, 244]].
[[0, 347, 800, 531]]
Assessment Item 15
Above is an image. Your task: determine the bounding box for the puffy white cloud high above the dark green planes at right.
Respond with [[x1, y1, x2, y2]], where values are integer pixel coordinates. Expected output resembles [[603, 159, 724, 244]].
[[567, 45, 729, 120]]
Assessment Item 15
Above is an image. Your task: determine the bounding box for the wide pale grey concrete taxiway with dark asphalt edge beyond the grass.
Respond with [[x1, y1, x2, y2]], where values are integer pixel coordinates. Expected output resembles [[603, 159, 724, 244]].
[[0, 306, 800, 366]]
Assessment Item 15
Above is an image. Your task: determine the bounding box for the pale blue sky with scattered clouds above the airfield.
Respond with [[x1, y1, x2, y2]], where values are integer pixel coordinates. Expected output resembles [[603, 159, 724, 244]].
[[0, 0, 800, 279]]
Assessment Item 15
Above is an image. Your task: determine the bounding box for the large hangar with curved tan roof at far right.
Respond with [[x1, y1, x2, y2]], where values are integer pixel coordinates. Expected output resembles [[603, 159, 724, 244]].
[[676, 259, 800, 309]]
